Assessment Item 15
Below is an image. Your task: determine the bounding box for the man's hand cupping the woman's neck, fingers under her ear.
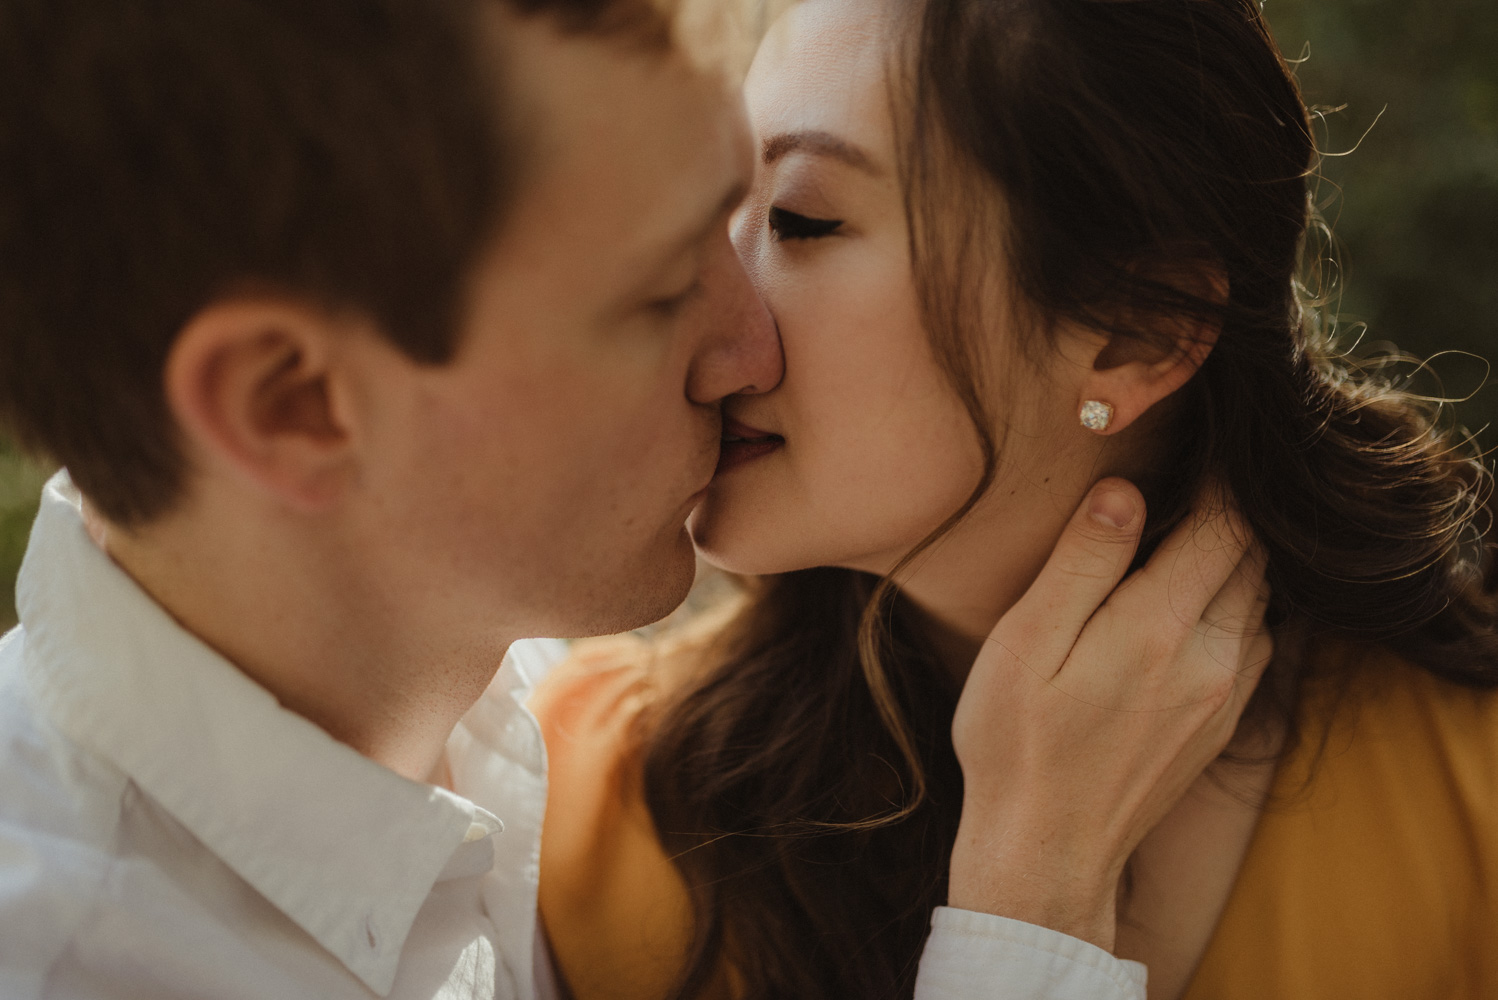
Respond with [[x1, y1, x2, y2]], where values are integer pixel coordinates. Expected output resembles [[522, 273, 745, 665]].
[[948, 479, 1273, 951]]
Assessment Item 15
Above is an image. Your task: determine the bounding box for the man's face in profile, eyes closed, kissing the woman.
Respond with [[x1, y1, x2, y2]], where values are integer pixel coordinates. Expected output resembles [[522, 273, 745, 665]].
[[364, 11, 782, 635]]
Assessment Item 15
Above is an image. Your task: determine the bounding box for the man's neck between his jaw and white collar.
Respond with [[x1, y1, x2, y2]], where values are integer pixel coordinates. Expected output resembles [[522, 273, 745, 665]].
[[98, 497, 508, 781]]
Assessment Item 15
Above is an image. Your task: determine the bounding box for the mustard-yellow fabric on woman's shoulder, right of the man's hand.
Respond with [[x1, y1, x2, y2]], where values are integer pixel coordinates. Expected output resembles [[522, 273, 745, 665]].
[[1186, 653, 1498, 1000]]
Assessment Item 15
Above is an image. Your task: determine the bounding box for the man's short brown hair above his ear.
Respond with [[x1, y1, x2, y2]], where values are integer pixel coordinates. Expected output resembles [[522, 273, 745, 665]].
[[0, 0, 644, 524]]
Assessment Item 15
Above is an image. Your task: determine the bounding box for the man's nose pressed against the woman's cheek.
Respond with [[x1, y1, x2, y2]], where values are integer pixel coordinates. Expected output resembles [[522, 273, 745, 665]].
[[686, 234, 785, 404]]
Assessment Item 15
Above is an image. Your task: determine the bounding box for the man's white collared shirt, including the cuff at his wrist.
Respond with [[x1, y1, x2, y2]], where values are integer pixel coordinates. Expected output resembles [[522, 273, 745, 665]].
[[0, 473, 1144, 1000]]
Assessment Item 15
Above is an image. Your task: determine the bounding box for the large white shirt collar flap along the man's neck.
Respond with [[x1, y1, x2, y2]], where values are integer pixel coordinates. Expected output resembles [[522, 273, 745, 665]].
[[16, 472, 500, 996]]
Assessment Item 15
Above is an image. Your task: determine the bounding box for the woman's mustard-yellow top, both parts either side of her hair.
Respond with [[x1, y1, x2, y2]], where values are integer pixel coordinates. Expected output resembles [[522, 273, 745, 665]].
[[532, 647, 1498, 1000]]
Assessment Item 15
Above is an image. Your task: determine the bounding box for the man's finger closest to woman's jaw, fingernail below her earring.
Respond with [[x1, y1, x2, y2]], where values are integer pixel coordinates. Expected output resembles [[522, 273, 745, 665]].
[[992, 479, 1144, 677]]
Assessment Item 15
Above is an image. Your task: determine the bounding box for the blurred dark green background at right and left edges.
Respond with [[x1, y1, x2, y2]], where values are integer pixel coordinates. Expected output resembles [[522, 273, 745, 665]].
[[0, 0, 1498, 626]]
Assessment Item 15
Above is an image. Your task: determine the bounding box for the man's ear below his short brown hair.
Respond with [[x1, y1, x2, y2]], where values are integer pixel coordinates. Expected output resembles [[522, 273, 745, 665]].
[[165, 298, 365, 512]]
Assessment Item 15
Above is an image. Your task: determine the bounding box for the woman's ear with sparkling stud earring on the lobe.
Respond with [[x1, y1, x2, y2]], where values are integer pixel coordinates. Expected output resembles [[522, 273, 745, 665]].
[[1077, 266, 1228, 434]]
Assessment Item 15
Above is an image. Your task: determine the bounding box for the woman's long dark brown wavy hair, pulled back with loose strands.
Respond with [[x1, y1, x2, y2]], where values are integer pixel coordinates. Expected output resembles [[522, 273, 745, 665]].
[[644, 0, 1498, 999]]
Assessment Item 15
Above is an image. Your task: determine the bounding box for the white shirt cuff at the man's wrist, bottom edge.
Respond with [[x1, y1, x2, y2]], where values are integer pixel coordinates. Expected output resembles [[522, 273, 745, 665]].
[[915, 906, 1147, 1000]]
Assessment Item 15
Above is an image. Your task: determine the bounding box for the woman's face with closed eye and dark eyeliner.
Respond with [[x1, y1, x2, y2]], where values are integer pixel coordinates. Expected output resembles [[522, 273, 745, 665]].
[[691, 0, 1097, 625]]
